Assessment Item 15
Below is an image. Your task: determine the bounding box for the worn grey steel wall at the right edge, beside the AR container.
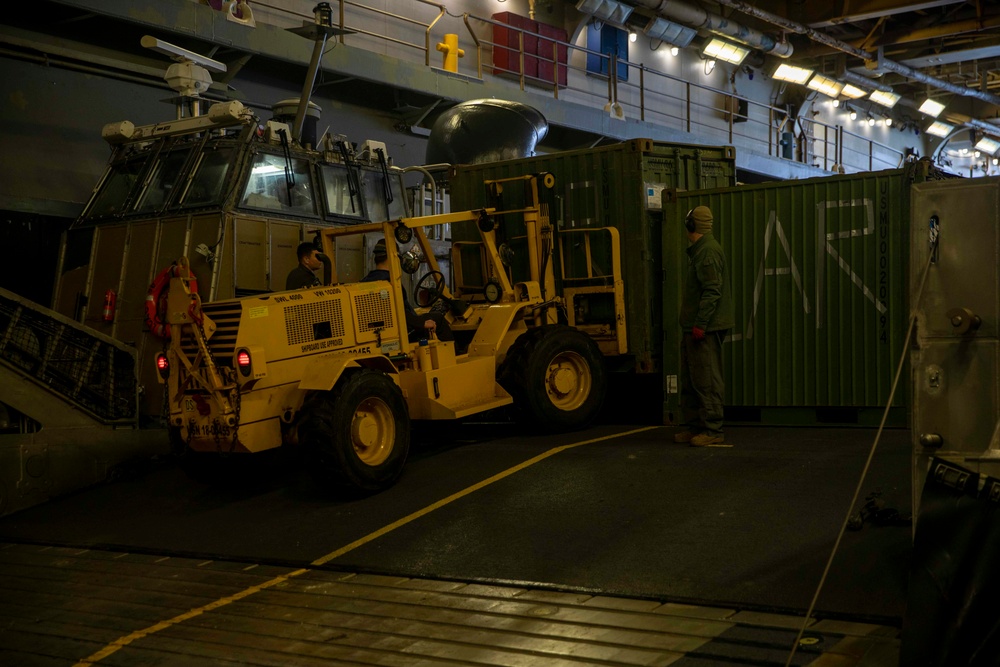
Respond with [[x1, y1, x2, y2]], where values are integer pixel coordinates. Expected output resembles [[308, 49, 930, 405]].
[[909, 178, 1000, 509]]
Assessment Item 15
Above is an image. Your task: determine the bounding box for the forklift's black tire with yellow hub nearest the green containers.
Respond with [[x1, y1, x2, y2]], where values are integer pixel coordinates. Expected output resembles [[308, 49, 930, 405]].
[[497, 324, 607, 431]]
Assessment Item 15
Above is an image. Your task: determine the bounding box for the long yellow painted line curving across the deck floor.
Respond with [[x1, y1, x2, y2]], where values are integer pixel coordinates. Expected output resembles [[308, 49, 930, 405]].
[[73, 426, 660, 667]]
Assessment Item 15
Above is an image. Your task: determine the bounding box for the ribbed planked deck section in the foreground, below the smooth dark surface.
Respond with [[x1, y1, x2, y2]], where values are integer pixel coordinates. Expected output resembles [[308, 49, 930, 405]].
[[0, 543, 899, 667]]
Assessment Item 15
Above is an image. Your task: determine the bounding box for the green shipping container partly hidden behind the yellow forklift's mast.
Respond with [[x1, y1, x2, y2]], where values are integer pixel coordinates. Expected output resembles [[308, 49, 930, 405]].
[[449, 139, 736, 373]]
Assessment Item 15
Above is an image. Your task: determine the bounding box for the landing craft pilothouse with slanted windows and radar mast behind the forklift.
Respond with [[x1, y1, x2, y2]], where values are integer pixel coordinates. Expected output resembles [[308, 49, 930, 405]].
[[54, 23, 409, 417]]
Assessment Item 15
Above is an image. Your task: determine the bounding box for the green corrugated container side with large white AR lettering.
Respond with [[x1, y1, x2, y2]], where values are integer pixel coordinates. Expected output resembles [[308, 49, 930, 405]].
[[664, 170, 911, 424]]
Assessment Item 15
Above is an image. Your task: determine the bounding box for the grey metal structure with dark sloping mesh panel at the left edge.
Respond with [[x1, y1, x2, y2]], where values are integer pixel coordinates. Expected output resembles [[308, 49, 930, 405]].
[[0, 288, 169, 515]]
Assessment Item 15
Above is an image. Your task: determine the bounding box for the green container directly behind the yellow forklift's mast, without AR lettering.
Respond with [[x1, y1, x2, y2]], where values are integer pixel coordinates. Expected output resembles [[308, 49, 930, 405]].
[[449, 139, 736, 373]]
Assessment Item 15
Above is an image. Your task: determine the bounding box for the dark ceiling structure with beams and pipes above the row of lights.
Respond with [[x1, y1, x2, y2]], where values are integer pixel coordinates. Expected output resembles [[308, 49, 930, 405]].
[[624, 0, 1000, 135]]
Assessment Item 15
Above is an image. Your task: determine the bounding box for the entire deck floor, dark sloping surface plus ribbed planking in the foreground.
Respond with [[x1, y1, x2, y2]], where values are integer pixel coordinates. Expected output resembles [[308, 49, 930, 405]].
[[0, 425, 910, 667]]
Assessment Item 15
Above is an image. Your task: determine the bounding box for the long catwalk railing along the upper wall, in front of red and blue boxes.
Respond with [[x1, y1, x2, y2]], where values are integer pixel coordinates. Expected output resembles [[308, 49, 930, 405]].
[[254, 0, 904, 173]]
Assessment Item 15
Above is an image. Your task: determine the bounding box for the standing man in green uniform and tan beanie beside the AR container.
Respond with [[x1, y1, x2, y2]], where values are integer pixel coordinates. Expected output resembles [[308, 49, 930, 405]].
[[674, 206, 735, 447]]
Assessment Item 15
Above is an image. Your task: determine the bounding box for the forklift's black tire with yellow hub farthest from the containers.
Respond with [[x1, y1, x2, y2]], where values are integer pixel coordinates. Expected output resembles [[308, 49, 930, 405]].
[[299, 368, 410, 497]]
